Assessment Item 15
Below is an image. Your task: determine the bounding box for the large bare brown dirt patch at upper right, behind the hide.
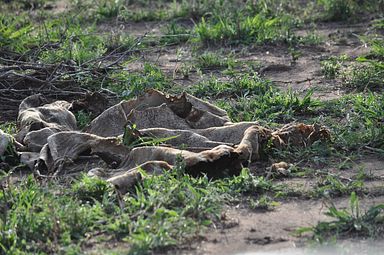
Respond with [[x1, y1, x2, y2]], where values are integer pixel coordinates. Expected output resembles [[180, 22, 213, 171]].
[[246, 23, 369, 100]]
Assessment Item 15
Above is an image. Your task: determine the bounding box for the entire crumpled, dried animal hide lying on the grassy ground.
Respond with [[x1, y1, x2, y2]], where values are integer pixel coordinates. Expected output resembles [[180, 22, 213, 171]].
[[0, 90, 330, 192]]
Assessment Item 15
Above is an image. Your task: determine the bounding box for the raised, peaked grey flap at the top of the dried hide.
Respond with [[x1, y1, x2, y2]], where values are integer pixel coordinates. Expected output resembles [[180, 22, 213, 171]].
[[87, 90, 229, 137]]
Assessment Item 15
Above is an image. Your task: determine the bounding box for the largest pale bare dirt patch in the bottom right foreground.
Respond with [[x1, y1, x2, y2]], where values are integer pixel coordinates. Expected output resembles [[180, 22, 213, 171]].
[[195, 196, 384, 254]]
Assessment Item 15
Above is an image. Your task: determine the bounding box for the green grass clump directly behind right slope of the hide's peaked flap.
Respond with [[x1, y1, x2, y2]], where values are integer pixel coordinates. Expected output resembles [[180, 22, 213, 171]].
[[189, 73, 321, 123]]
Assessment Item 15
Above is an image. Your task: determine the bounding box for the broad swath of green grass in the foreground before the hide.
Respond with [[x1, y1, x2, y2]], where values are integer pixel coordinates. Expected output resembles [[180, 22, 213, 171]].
[[0, 167, 282, 254]]
